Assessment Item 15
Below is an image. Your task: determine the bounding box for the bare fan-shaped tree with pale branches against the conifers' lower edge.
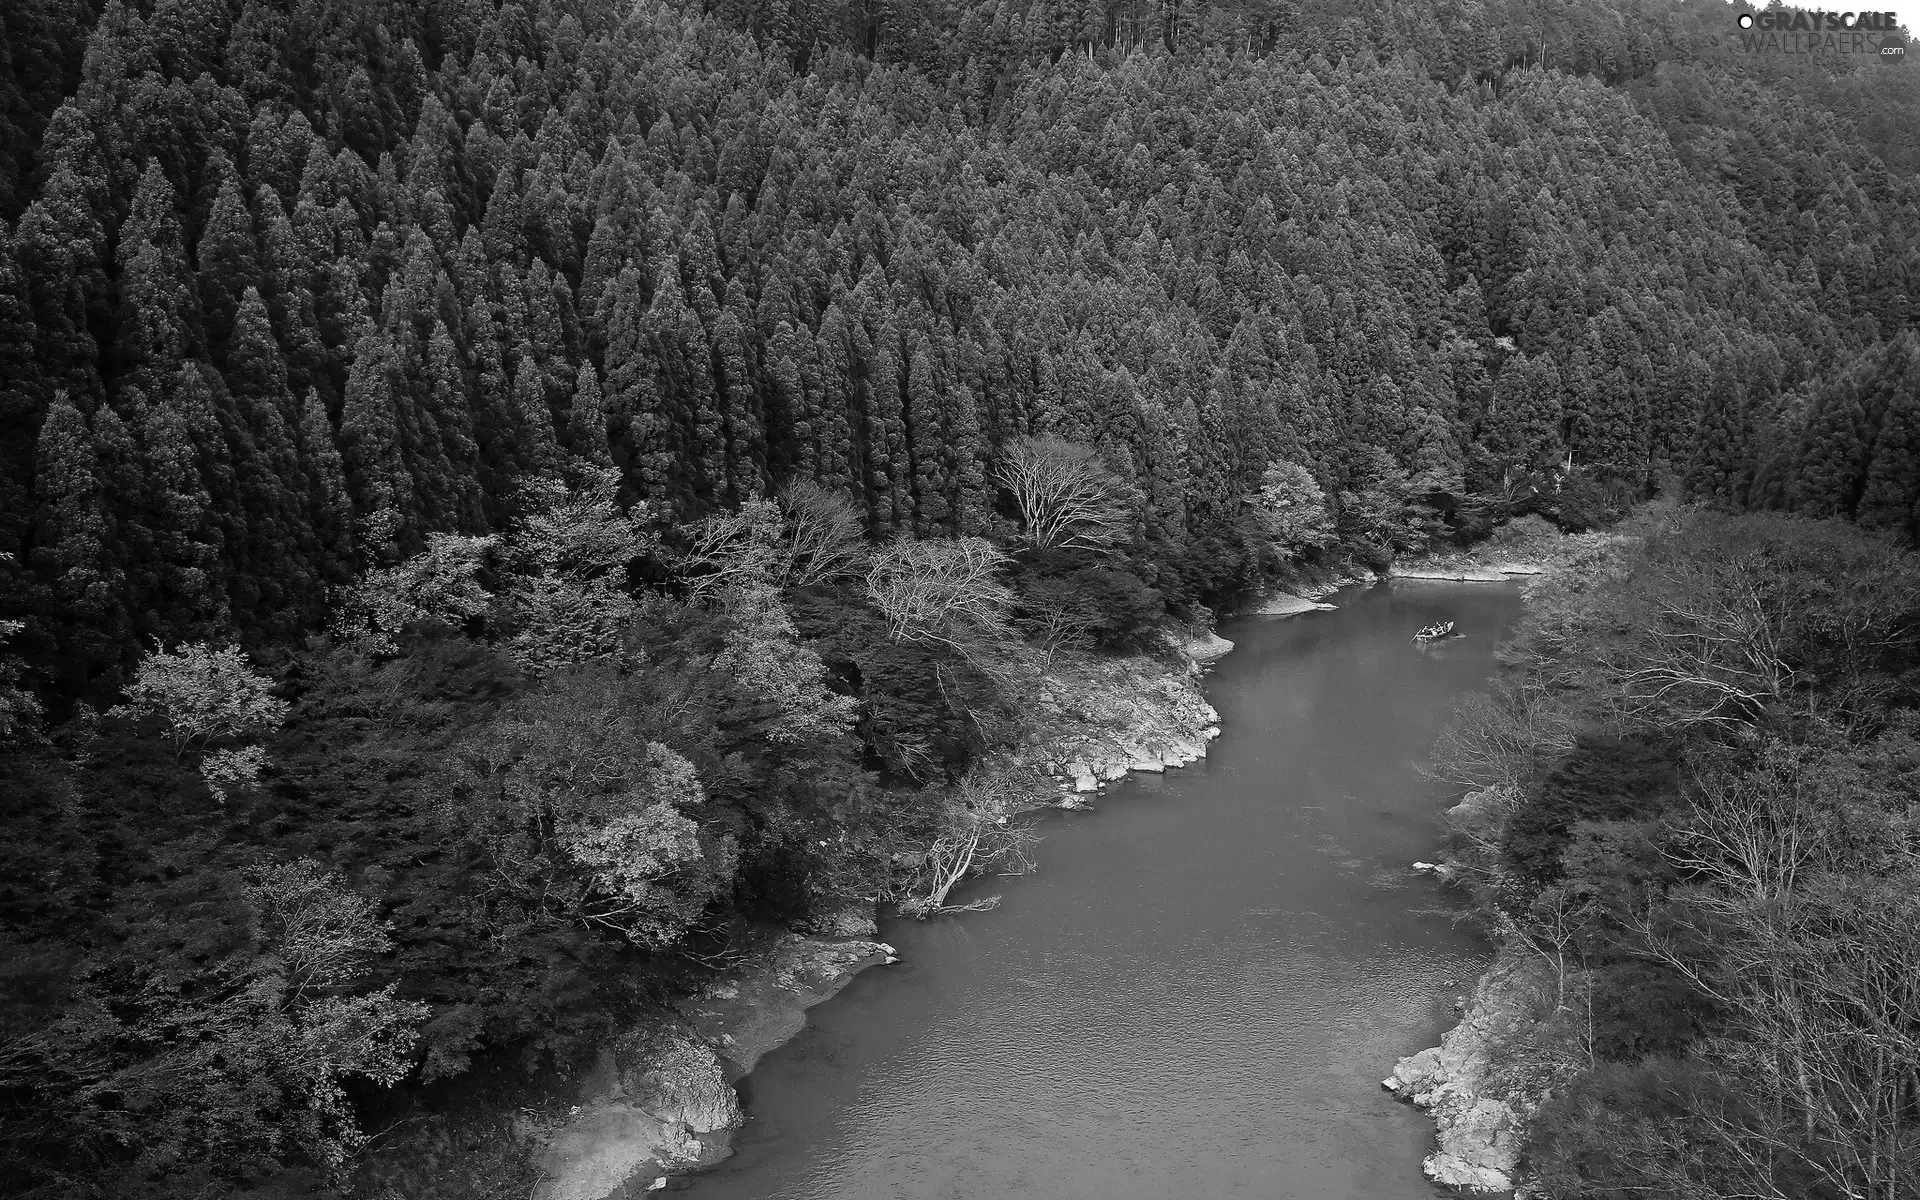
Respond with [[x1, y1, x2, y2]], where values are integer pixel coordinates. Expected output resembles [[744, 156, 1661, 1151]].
[[998, 438, 1133, 551]]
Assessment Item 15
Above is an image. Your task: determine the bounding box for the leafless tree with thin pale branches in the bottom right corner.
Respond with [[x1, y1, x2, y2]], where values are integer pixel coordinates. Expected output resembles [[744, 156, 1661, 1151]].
[[1638, 753, 1920, 1200]]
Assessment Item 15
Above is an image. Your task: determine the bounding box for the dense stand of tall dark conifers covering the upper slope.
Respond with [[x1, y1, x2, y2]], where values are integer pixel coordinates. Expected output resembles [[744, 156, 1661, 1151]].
[[0, 2, 1916, 702]]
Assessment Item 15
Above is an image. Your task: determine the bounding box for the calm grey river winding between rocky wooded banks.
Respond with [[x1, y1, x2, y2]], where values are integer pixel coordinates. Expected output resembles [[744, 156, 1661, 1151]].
[[674, 582, 1521, 1200]]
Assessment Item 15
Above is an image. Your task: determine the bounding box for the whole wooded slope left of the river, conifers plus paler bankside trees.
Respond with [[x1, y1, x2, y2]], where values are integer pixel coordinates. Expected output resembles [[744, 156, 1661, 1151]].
[[0, 0, 1920, 1196]]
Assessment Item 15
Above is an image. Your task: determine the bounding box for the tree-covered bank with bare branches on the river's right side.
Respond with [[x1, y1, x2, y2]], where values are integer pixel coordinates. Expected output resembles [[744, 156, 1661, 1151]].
[[1438, 509, 1920, 1200]]
